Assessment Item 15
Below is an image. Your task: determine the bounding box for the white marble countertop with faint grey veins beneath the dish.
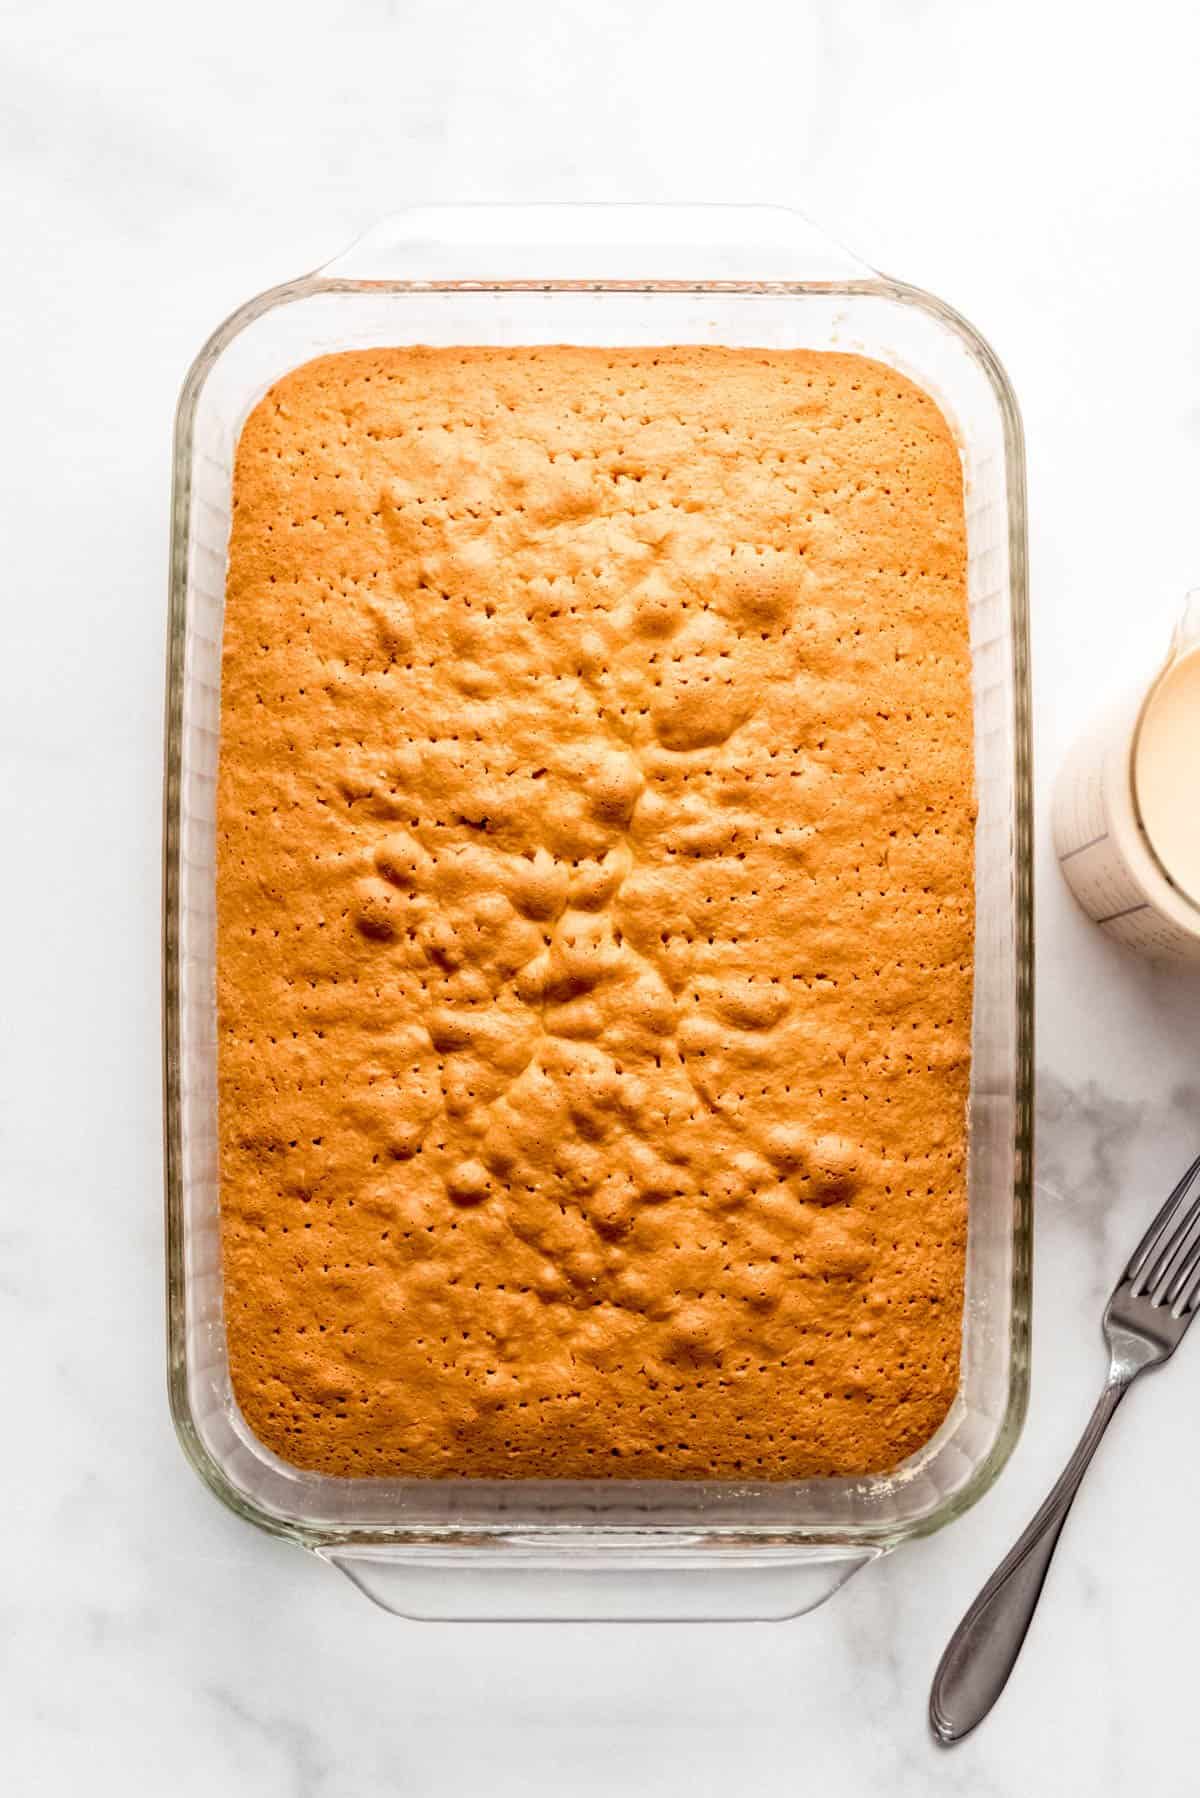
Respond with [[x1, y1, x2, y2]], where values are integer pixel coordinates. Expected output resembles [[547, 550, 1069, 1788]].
[[0, 0, 1200, 1798]]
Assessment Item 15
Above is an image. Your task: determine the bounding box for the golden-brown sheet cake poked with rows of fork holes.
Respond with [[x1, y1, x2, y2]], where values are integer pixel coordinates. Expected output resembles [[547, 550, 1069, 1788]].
[[218, 349, 975, 1480]]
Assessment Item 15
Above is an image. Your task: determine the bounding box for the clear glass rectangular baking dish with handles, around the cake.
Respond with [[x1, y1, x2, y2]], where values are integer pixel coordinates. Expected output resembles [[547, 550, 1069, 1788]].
[[164, 207, 1033, 1618]]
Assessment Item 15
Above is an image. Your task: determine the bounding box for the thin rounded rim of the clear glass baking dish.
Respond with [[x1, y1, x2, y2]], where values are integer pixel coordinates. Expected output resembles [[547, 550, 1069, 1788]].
[[164, 228, 1033, 1575]]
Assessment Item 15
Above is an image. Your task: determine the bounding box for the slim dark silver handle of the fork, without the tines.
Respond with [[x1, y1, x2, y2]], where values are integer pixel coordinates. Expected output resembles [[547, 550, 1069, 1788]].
[[928, 1375, 1128, 1744]]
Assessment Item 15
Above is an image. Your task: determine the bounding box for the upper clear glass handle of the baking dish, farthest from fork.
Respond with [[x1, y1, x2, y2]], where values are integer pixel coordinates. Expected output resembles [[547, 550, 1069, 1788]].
[[318, 205, 878, 286]]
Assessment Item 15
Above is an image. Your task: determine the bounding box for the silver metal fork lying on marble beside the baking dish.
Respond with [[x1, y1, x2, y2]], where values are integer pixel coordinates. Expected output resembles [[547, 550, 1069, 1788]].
[[928, 1156, 1200, 1744]]
